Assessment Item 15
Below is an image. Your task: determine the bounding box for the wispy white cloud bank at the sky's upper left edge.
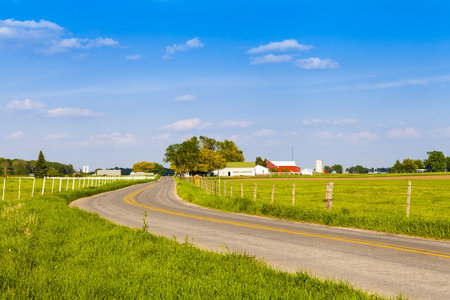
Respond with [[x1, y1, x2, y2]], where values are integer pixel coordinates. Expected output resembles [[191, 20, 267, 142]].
[[0, 19, 119, 54]]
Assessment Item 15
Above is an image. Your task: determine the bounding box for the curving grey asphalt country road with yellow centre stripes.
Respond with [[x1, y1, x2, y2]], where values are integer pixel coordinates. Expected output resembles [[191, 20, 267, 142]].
[[71, 177, 450, 299]]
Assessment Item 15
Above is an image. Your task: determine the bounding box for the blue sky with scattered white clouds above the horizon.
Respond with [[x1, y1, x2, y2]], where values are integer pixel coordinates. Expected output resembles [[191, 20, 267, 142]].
[[0, 0, 450, 169]]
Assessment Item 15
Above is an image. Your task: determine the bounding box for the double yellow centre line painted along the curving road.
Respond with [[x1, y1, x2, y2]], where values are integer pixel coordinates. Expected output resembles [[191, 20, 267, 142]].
[[124, 179, 450, 258]]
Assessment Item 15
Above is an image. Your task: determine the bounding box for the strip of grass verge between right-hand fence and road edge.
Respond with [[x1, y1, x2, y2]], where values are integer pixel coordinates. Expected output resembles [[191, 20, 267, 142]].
[[177, 180, 450, 239]]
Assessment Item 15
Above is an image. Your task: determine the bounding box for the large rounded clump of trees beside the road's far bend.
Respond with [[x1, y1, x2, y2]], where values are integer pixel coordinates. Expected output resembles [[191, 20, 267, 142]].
[[163, 136, 245, 176]]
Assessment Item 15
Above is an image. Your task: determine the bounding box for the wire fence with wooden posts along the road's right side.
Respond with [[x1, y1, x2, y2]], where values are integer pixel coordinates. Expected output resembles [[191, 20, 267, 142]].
[[185, 177, 450, 219]]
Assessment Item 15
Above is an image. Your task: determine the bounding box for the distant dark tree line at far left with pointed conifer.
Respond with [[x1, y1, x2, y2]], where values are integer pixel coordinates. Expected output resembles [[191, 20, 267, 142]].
[[0, 151, 75, 177]]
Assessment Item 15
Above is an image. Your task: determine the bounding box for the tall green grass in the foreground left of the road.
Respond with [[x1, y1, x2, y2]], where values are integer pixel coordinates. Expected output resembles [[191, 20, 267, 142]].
[[0, 178, 390, 299]]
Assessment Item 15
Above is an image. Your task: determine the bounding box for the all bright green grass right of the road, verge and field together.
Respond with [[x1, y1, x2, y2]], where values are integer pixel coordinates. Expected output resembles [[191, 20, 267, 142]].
[[179, 177, 450, 239]]
